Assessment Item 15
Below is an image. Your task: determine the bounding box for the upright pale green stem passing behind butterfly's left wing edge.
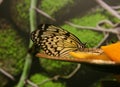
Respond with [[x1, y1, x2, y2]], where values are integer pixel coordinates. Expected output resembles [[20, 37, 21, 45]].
[[17, 0, 37, 87]]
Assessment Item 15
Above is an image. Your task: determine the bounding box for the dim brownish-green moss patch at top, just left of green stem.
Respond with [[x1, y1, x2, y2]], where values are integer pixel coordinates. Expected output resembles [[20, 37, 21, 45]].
[[10, 0, 30, 32]]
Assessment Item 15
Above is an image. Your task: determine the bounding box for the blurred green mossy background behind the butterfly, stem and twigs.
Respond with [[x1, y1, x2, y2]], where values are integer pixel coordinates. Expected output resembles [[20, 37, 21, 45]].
[[0, 0, 120, 87]]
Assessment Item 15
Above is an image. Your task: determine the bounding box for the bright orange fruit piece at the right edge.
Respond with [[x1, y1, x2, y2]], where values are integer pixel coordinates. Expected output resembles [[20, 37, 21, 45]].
[[101, 42, 120, 62]]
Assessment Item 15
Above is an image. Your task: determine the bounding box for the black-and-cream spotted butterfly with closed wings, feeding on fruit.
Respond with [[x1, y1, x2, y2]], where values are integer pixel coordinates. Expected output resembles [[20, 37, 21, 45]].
[[31, 24, 85, 57]]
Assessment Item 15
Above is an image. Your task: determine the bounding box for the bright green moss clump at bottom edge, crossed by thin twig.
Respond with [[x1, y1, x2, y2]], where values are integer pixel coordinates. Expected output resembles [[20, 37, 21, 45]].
[[27, 74, 66, 87]]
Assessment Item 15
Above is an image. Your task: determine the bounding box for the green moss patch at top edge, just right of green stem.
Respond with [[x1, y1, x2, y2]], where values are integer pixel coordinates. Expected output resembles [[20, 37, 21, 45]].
[[38, 0, 74, 23]]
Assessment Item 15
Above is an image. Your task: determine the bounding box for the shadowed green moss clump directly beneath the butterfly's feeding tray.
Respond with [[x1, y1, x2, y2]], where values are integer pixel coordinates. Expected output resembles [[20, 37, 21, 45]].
[[40, 59, 77, 75]]
